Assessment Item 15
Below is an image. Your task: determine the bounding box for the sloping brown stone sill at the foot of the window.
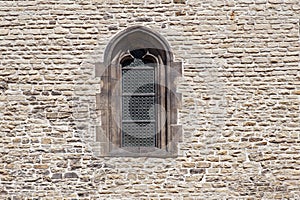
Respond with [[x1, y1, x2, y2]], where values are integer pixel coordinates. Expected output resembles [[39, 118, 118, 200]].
[[103, 147, 177, 158]]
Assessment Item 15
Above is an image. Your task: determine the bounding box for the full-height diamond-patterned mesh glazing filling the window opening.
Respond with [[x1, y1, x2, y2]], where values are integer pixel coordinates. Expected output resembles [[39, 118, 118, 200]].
[[122, 59, 156, 147]]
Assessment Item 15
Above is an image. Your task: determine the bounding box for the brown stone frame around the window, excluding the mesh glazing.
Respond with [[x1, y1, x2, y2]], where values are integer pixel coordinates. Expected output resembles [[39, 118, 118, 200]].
[[95, 26, 182, 157]]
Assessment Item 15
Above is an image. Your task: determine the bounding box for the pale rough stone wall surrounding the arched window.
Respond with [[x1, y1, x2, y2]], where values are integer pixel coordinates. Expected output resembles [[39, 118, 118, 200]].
[[0, 0, 300, 199]]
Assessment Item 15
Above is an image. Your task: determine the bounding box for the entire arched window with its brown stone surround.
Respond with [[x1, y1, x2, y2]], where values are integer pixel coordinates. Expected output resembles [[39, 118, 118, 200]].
[[96, 26, 181, 156]]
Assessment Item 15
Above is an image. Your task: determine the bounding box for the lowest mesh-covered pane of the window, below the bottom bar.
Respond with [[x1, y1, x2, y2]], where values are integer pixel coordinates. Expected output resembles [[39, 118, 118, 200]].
[[122, 123, 155, 147]]
